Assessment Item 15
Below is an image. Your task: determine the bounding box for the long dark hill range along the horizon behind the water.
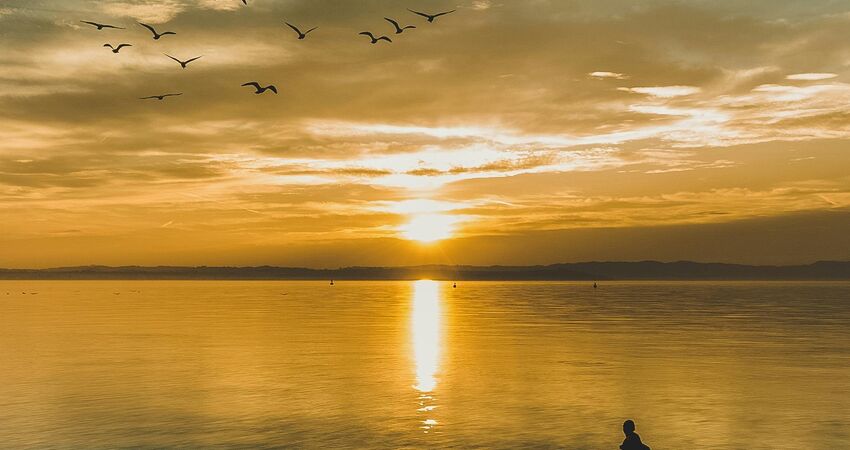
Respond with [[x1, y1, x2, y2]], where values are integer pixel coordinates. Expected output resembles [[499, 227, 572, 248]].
[[0, 261, 850, 281]]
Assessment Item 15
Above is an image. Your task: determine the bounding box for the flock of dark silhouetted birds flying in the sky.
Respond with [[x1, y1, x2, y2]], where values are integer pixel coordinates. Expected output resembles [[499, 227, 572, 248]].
[[80, 0, 456, 101]]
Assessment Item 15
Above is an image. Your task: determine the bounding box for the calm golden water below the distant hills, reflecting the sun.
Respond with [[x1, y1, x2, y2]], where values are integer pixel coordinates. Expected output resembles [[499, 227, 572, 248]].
[[0, 281, 850, 450]]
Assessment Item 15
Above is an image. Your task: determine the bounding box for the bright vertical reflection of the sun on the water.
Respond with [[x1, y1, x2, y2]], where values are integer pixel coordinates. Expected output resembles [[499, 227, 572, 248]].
[[411, 280, 441, 433]]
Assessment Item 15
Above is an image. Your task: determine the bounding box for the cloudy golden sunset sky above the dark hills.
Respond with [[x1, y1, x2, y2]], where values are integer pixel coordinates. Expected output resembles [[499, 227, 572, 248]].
[[0, 0, 850, 267]]
